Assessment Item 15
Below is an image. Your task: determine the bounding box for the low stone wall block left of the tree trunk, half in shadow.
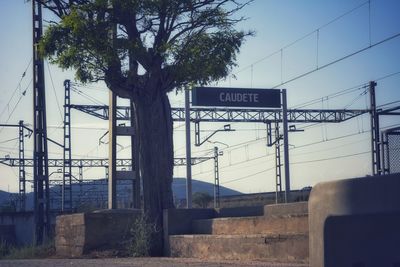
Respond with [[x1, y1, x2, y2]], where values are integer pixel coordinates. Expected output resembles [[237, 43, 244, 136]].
[[55, 209, 141, 257]]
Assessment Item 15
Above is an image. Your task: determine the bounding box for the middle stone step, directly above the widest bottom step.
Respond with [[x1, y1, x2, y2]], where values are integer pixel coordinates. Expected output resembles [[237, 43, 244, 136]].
[[192, 214, 308, 235]]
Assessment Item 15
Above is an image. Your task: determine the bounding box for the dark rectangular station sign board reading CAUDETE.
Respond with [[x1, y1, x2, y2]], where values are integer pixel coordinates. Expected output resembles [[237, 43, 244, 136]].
[[192, 87, 281, 108]]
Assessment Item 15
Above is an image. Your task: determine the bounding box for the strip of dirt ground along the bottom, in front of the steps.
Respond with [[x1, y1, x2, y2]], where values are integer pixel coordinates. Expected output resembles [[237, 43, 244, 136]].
[[0, 258, 308, 267]]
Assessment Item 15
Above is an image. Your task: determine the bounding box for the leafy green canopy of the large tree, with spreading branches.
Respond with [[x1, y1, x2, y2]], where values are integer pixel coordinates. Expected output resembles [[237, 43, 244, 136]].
[[41, 0, 252, 97]]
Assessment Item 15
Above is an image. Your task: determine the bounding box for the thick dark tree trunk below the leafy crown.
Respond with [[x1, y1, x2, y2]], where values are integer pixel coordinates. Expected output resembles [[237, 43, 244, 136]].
[[134, 93, 174, 256]]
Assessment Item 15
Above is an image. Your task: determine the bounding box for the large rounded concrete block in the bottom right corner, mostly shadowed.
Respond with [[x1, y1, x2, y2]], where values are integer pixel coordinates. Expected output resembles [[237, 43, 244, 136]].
[[309, 174, 400, 267]]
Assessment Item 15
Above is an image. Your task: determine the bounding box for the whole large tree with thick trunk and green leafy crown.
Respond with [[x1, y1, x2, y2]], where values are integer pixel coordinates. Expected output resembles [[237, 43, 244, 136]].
[[36, 0, 252, 255]]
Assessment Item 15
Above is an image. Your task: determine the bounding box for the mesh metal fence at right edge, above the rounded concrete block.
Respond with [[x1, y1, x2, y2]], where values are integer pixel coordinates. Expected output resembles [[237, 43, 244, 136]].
[[382, 127, 400, 174]]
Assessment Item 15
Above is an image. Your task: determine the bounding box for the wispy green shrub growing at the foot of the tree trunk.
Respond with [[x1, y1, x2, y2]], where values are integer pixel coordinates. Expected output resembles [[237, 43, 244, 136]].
[[126, 214, 157, 257]]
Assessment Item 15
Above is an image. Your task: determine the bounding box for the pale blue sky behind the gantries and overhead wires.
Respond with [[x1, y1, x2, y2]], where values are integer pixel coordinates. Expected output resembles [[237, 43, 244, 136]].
[[0, 0, 400, 196]]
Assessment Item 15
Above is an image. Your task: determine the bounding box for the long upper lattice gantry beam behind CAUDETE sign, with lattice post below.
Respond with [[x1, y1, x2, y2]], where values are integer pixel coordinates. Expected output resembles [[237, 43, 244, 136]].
[[71, 102, 370, 202]]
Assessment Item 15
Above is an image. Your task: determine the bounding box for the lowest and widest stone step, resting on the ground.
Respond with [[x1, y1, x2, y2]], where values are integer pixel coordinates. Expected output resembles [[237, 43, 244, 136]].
[[169, 234, 308, 263]]
